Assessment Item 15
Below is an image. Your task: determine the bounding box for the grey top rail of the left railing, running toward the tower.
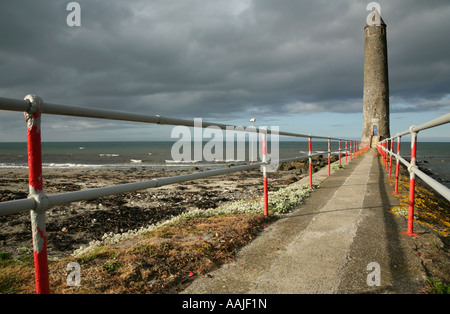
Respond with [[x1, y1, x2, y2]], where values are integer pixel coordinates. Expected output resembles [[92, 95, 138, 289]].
[[0, 97, 349, 141]]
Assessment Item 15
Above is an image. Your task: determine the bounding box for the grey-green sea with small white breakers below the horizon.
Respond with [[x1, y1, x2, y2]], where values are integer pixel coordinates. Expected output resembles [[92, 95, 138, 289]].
[[0, 140, 450, 186]]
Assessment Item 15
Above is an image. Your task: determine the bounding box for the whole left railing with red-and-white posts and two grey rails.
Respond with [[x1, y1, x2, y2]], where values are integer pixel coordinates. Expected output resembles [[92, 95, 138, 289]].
[[0, 95, 368, 294]]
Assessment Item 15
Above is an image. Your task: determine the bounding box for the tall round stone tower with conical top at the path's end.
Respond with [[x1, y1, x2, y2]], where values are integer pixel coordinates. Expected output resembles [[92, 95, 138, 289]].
[[361, 9, 390, 147]]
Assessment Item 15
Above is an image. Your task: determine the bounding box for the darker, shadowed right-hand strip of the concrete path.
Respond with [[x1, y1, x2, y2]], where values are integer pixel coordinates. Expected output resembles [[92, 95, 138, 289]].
[[337, 151, 425, 293]]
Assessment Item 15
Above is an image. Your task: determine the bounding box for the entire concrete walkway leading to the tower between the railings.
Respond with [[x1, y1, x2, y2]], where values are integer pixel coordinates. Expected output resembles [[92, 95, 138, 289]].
[[183, 149, 426, 294]]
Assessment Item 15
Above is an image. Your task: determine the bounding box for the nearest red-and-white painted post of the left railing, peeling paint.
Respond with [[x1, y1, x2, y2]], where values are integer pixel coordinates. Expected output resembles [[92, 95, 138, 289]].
[[24, 95, 50, 294]]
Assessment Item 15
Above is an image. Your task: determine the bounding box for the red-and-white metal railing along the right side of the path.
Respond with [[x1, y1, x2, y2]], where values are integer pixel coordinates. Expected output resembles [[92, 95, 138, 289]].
[[378, 113, 450, 236]]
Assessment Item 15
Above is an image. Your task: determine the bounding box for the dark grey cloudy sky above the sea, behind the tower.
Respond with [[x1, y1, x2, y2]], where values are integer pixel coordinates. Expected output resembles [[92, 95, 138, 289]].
[[0, 0, 450, 141]]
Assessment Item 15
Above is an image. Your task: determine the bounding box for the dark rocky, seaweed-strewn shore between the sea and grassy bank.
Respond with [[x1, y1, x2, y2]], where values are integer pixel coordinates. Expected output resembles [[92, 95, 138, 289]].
[[0, 156, 337, 258]]
